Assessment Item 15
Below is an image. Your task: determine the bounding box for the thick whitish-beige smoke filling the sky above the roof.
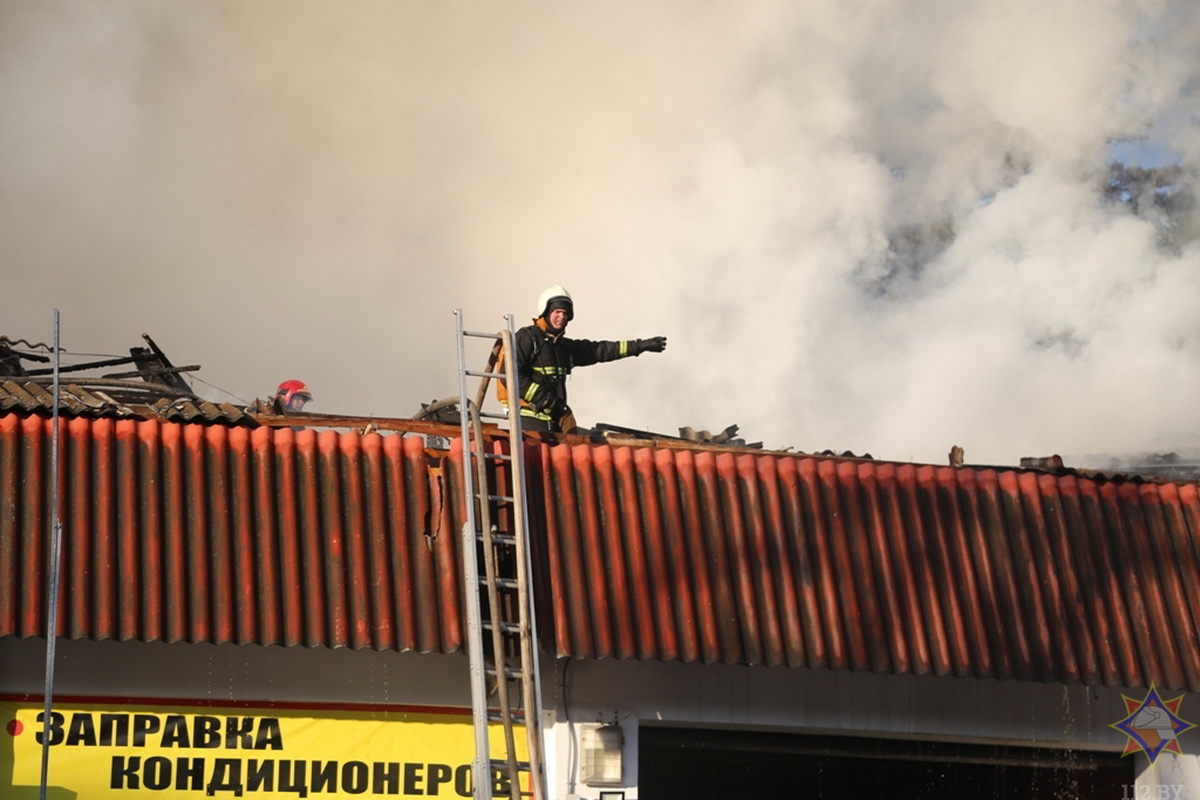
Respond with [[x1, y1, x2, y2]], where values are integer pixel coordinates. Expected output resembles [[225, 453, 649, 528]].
[[0, 0, 1200, 463]]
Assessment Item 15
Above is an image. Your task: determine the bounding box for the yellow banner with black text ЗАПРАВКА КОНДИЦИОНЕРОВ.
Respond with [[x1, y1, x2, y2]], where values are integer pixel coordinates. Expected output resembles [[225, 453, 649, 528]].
[[0, 702, 528, 800]]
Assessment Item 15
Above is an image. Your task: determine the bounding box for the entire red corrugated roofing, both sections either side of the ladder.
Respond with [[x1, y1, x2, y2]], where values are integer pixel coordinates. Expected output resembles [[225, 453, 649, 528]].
[[0, 415, 1200, 691]]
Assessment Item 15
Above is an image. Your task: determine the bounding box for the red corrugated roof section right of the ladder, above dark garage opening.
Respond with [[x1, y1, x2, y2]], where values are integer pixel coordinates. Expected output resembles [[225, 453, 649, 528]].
[[529, 445, 1200, 691]]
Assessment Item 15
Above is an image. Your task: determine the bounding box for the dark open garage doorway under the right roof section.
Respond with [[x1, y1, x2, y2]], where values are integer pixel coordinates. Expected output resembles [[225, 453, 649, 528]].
[[637, 726, 1134, 800]]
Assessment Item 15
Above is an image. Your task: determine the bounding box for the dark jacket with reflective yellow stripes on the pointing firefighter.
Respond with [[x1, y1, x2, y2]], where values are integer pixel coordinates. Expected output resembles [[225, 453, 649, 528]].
[[497, 317, 637, 423]]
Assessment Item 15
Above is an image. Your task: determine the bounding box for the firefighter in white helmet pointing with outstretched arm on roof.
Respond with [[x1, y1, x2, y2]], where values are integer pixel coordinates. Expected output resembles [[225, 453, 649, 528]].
[[497, 284, 667, 433]]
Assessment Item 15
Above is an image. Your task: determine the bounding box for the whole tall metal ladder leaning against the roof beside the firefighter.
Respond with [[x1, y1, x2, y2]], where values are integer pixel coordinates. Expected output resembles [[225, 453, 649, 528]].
[[455, 308, 546, 800]]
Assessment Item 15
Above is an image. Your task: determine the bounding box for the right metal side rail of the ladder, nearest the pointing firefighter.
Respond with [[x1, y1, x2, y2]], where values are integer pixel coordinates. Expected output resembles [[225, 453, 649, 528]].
[[504, 314, 546, 800]]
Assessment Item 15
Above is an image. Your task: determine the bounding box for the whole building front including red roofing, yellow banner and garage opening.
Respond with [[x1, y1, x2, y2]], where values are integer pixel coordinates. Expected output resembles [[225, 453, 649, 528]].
[[0, 408, 1200, 800]]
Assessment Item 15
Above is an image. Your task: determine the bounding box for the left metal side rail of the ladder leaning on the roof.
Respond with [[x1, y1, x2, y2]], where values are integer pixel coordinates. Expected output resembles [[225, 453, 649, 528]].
[[454, 308, 492, 800]]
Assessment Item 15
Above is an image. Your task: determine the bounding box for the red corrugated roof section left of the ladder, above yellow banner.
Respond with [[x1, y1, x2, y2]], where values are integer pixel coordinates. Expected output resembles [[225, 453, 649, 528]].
[[0, 415, 461, 651]]
